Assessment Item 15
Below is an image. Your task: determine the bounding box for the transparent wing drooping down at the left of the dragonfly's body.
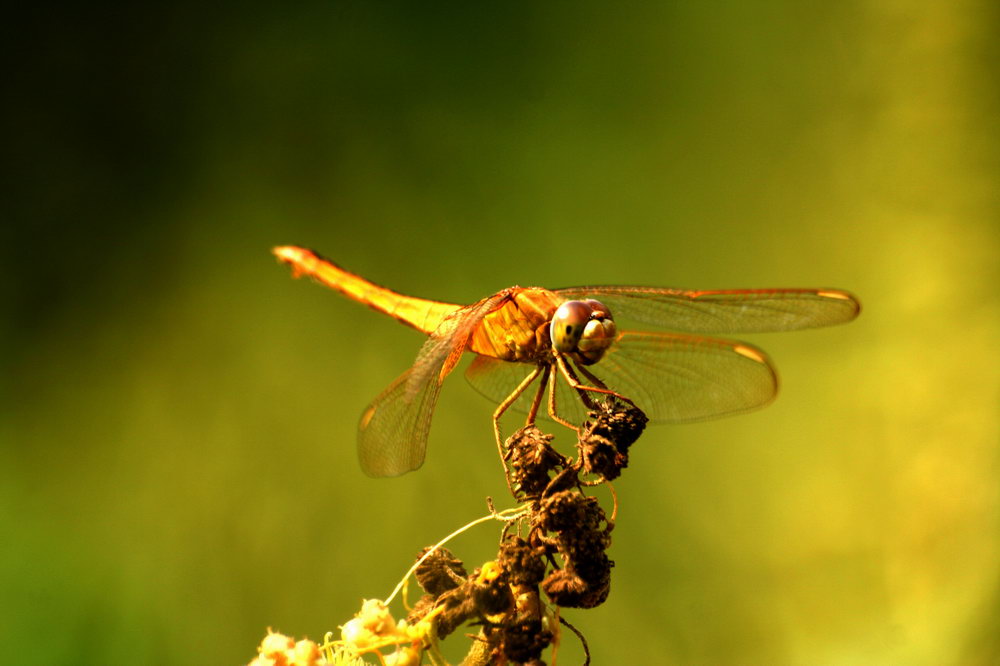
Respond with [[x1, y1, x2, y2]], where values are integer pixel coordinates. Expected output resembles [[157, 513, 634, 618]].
[[358, 294, 501, 476]]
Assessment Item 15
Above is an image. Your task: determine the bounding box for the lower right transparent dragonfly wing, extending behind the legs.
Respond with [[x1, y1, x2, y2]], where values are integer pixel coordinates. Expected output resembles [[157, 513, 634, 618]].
[[466, 332, 778, 423]]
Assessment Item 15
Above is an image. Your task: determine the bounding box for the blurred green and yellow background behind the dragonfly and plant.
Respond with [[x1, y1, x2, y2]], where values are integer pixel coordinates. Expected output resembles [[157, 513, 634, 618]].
[[0, 0, 1000, 665]]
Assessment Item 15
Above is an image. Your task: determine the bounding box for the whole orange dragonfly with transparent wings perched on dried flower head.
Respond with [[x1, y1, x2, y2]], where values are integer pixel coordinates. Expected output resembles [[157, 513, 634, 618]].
[[273, 245, 861, 477]]
